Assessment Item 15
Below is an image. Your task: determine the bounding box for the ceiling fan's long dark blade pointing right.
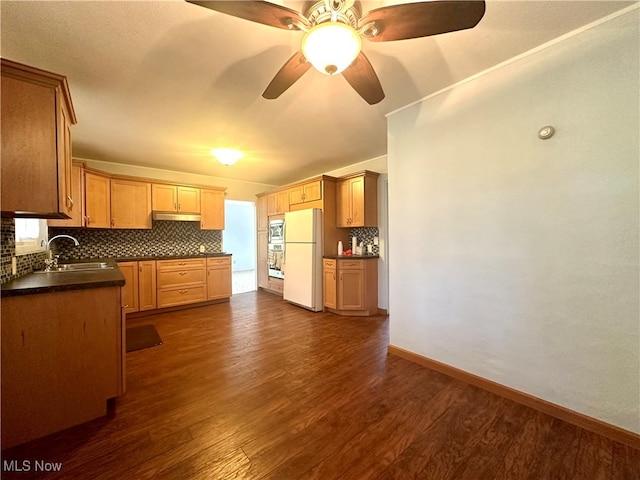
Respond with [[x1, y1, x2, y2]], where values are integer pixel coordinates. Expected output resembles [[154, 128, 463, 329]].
[[358, 0, 485, 42]]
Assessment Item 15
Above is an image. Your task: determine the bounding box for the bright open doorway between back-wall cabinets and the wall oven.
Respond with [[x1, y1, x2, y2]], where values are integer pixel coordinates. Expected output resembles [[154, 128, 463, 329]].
[[222, 200, 257, 295]]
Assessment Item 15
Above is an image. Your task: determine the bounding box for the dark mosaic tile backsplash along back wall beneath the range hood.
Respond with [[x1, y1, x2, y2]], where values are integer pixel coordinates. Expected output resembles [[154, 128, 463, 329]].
[[49, 221, 222, 260]]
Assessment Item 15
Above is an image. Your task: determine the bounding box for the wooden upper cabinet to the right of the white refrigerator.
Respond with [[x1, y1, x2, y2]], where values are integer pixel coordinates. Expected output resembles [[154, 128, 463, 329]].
[[336, 171, 378, 228]]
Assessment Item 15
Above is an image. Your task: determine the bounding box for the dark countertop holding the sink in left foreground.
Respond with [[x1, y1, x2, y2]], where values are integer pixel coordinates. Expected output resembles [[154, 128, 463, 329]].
[[2, 259, 124, 297]]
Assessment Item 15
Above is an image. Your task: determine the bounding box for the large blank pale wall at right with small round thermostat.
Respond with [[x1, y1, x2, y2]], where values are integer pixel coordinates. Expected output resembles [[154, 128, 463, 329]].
[[388, 8, 640, 433]]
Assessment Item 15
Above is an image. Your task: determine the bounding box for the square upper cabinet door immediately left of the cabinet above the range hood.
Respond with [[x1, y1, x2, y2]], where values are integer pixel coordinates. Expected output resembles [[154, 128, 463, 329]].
[[111, 179, 151, 228]]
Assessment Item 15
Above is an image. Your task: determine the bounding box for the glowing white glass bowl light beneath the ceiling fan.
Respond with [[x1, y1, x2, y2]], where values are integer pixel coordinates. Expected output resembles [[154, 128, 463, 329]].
[[302, 22, 362, 75]]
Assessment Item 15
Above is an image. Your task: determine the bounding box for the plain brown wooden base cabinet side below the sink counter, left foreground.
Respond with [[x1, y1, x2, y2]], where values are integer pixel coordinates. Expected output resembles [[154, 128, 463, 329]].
[[1, 286, 125, 449]]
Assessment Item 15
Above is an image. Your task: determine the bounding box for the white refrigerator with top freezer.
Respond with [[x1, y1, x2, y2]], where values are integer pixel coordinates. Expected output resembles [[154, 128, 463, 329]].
[[284, 208, 323, 312]]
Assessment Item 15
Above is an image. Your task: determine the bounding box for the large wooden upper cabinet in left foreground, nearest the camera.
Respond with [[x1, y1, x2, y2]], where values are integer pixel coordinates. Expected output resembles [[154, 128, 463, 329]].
[[0, 58, 79, 218]]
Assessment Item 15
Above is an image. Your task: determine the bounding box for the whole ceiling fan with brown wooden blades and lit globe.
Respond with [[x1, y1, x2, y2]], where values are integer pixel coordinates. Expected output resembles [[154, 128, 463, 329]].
[[186, 0, 485, 105]]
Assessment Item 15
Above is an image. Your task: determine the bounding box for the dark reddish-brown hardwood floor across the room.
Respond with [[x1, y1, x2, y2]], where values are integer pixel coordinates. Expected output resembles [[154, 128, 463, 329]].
[[2, 292, 640, 480]]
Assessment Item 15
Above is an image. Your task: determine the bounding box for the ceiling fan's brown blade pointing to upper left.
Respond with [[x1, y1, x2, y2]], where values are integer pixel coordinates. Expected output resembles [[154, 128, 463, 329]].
[[186, 0, 308, 30]]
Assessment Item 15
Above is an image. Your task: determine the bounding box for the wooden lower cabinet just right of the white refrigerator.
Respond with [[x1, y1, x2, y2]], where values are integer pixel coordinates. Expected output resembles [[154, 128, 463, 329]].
[[323, 257, 378, 316]]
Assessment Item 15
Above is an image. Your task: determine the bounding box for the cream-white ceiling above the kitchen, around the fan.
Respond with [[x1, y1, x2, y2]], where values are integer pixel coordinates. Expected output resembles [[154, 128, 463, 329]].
[[1, 0, 637, 185]]
